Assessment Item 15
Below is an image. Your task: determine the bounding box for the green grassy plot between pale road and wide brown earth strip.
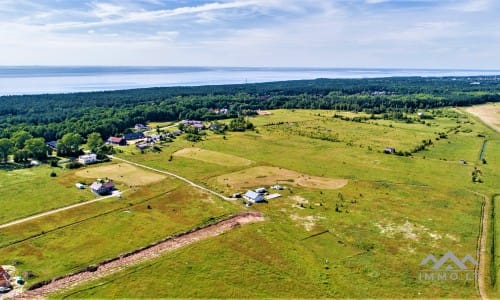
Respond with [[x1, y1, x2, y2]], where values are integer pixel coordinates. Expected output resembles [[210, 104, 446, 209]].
[[0, 179, 235, 284]]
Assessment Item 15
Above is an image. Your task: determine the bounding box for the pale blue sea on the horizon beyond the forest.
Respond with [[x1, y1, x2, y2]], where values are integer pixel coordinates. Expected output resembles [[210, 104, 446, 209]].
[[0, 66, 500, 96]]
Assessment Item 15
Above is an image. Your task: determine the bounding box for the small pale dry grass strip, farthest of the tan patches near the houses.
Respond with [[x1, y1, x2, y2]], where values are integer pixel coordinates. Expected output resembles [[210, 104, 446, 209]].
[[174, 147, 252, 167]]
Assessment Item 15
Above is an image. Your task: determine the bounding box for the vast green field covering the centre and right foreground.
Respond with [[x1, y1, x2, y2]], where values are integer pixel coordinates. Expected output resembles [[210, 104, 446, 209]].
[[44, 109, 500, 298]]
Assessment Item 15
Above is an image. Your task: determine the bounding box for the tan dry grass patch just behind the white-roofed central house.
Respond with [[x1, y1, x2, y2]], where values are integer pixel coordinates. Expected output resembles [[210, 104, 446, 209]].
[[217, 166, 348, 189]]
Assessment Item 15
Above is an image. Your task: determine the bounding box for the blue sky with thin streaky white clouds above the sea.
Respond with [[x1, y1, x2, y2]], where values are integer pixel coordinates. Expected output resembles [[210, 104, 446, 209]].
[[0, 0, 500, 69]]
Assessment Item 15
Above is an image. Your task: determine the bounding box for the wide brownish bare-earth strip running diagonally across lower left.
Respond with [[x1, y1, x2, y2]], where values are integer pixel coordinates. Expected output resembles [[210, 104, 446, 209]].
[[14, 212, 264, 299]]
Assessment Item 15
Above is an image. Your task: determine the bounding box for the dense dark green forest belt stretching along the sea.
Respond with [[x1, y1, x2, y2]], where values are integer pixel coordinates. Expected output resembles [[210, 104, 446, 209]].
[[0, 76, 500, 141]]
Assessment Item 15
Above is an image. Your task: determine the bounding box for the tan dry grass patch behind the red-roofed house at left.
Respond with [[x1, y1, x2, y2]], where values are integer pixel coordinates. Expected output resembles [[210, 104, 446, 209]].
[[76, 163, 166, 186]]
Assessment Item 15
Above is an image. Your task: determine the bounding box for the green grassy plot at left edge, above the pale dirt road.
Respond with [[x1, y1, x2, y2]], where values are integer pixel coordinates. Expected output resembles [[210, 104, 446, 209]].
[[0, 165, 95, 224]]
